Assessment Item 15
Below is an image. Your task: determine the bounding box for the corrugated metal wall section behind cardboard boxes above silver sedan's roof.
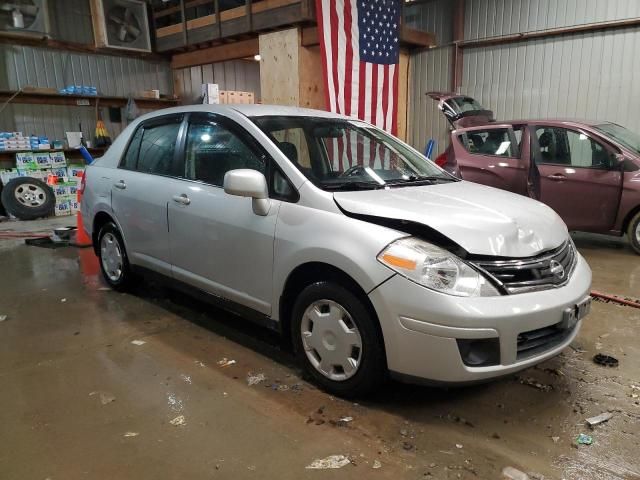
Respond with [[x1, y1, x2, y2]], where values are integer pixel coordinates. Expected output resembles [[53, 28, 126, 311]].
[[173, 60, 260, 105]]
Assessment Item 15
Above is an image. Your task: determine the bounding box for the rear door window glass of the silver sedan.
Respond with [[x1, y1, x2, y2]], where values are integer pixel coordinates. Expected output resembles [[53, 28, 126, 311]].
[[136, 122, 184, 177]]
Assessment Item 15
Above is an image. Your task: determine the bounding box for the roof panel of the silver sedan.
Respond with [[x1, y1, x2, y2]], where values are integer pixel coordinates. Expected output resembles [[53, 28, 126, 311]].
[[134, 104, 349, 120]]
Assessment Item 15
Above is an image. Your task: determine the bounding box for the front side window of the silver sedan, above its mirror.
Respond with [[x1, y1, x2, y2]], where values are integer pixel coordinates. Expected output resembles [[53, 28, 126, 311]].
[[186, 119, 267, 187]]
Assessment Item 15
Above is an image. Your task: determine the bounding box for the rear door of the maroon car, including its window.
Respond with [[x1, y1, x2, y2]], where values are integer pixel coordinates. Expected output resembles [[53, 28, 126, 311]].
[[451, 125, 529, 195]]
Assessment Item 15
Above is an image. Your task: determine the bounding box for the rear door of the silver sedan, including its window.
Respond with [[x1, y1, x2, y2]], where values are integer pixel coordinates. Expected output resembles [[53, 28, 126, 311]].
[[111, 115, 184, 275]]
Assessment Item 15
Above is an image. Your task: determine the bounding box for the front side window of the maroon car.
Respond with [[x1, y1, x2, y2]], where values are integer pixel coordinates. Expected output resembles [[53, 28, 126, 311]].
[[536, 127, 612, 170]]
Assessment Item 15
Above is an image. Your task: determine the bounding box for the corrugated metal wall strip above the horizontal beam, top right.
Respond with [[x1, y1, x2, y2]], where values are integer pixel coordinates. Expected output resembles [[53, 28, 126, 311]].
[[464, 0, 640, 40]]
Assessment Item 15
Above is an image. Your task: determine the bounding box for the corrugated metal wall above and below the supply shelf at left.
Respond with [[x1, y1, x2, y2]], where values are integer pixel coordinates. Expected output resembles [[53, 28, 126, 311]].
[[0, 45, 173, 139]]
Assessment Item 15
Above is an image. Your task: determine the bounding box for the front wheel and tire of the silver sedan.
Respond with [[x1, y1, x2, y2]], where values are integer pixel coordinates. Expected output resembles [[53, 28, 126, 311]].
[[291, 281, 387, 397]]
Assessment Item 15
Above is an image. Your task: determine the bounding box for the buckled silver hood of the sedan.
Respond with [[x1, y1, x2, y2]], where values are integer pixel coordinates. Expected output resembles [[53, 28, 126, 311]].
[[334, 181, 568, 257]]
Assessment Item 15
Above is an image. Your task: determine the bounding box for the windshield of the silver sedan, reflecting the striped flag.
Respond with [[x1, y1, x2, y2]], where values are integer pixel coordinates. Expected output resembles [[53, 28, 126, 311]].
[[254, 117, 457, 190]]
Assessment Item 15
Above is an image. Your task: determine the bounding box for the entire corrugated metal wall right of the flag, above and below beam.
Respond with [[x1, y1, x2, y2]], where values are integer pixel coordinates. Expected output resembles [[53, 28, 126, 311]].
[[410, 0, 640, 152]]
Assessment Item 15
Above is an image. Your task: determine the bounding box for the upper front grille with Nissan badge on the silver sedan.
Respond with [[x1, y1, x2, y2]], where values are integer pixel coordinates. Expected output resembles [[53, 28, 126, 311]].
[[471, 240, 577, 294]]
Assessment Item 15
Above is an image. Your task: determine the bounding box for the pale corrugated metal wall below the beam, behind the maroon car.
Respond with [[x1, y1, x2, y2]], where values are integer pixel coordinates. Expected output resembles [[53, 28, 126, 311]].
[[462, 28, 640, 131]]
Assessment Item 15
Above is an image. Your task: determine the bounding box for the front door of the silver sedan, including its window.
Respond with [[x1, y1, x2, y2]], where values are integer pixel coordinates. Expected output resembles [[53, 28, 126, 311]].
[[168, 114, 280, 315]]
